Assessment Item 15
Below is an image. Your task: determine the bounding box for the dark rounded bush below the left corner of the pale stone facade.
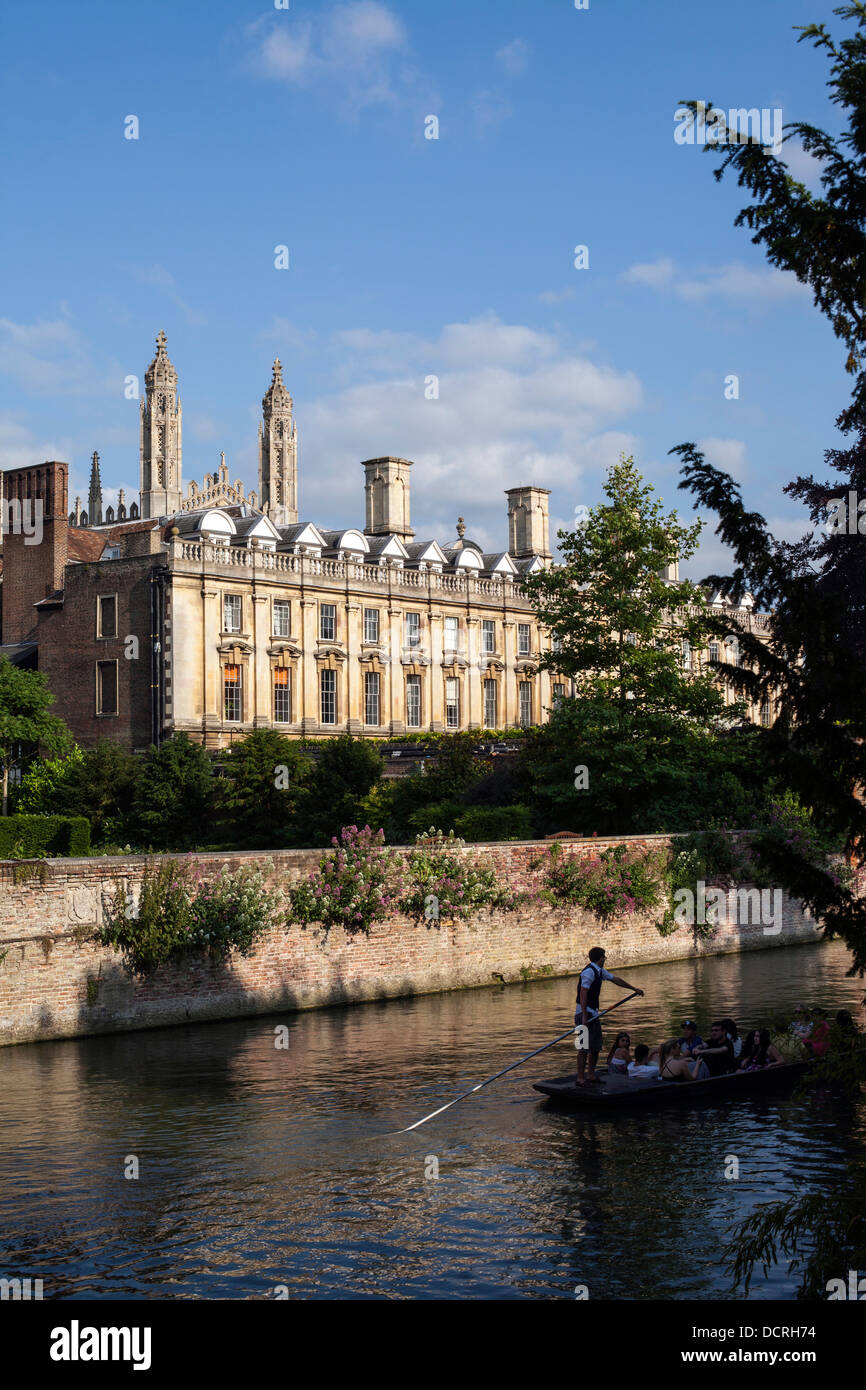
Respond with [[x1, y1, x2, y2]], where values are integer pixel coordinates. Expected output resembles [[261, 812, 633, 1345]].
[[131, 734, 220, 849]]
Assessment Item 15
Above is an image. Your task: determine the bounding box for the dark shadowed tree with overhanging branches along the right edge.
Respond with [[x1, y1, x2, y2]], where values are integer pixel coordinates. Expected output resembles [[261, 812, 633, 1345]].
[[671, 0, 866, 1298]]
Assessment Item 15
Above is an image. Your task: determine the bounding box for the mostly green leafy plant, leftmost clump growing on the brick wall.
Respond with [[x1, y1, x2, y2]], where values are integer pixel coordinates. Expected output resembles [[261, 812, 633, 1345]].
[[95, 859, 281, 976]]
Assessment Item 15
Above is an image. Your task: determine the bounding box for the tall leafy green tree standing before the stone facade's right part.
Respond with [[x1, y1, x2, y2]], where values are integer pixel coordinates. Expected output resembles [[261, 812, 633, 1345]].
[[524, 459, 744, 831]]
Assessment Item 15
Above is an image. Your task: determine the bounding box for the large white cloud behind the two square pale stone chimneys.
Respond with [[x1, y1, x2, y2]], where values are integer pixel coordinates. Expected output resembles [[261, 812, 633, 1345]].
[[291, 314, 642, 549]]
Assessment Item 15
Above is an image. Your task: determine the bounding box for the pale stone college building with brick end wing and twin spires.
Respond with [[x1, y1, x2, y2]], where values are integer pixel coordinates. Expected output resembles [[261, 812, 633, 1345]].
[[3, 334, 769, 749]]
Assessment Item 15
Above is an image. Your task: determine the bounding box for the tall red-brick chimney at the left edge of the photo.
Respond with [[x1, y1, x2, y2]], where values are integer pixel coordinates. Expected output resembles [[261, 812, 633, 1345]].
[[3, 463, 70, 642]]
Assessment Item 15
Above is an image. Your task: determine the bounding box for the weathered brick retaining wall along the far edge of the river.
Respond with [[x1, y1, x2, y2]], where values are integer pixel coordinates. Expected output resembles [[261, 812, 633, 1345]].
[[0, 835, 820, 1044]]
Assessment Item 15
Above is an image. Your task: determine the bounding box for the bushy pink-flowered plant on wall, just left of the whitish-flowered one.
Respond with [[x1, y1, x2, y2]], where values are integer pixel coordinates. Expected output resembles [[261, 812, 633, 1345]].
[[289, 826, 403, 935]]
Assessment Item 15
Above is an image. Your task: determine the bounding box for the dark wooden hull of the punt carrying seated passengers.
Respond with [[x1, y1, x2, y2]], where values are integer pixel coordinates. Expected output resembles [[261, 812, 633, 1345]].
[[532, 1061, 810, 1115]]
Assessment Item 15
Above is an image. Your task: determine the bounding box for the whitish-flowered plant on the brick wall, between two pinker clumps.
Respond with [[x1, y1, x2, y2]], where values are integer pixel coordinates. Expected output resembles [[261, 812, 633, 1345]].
[[399, 826, 523, 922]]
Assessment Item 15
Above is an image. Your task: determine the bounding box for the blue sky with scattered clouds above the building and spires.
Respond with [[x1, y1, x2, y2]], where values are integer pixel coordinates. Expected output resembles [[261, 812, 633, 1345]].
[[0, 0, 849, 575]]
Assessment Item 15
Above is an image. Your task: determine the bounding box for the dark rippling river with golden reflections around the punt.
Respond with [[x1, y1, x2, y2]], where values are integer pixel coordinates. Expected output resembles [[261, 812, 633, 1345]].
[[0, 942, 866, 1300]]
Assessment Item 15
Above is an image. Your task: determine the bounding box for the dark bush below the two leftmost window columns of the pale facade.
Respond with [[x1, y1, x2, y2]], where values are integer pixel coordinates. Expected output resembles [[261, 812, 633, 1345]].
[[224, 728, 313, 849]]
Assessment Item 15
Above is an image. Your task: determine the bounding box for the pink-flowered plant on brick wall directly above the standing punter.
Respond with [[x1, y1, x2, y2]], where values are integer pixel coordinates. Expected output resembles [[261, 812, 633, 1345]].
[[542, 845, 664, 923]]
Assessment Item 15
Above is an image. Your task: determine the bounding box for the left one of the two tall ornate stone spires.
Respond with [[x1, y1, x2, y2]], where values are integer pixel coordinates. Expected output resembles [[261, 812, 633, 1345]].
[[139, 329, 183, 517]]
